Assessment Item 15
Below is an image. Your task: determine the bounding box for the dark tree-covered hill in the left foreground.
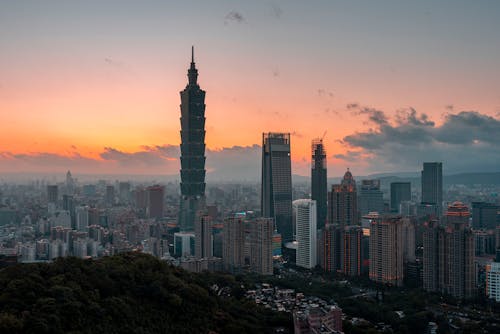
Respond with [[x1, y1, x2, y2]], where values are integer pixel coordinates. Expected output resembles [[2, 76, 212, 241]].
[[0, 253, 292, 334]]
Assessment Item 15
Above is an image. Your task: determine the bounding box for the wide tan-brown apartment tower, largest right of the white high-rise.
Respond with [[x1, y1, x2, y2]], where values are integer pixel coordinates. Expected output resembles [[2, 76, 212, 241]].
[[370, 215, 404, 286]]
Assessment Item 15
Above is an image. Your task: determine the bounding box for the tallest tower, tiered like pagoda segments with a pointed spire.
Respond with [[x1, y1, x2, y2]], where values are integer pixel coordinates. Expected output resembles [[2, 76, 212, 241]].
[[179, 48, 205, 231]]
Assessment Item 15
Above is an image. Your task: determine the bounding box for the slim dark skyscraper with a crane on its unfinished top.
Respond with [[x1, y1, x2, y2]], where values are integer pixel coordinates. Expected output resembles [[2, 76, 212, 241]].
[[311, 139, 328, 229]]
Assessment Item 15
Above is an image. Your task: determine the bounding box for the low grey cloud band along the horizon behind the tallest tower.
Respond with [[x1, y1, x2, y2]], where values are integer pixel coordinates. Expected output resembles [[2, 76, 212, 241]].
[[0, 145, 262, 181]]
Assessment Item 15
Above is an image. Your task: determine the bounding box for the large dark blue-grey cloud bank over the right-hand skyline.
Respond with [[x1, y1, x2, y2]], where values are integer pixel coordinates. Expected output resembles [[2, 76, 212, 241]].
[[335, 108, 500, 172]]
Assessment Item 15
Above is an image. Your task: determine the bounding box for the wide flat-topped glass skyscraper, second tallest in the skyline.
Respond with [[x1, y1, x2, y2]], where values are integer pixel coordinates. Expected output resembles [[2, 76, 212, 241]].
[[261, 133, 293, 243]]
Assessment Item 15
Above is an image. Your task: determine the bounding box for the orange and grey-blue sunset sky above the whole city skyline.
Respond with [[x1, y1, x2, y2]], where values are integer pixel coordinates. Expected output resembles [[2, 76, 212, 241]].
[[0, 0, 500, 179]]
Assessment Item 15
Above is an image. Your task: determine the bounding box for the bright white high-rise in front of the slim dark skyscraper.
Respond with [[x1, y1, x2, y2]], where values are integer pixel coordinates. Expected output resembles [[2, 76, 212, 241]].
[[292, 199, 317, 269]]
